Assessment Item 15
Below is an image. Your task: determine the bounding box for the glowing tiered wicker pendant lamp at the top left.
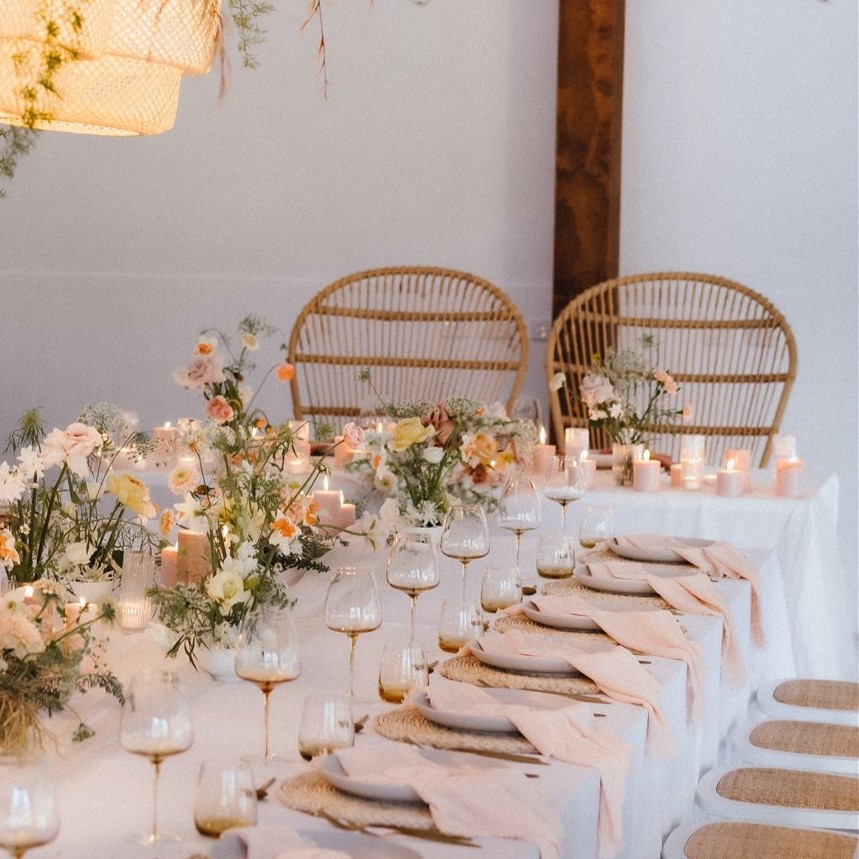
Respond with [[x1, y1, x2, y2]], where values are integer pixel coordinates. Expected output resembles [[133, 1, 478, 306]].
[[0, 0, 221, 136]]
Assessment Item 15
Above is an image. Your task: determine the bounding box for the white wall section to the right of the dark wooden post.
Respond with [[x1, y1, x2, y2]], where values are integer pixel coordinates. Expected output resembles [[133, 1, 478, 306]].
[[621, 0, 859, 604]]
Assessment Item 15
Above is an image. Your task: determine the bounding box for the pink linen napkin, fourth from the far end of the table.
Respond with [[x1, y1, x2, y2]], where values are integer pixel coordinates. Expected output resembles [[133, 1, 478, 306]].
[[480, 629, 675, 759]]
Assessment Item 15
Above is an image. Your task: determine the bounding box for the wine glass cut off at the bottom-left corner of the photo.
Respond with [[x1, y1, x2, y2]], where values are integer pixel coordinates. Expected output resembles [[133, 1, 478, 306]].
[[0, 755, 60, 859]]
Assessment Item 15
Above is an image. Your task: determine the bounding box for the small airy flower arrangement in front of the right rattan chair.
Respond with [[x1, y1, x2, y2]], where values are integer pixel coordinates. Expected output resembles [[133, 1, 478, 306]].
[[579, 335, 690, 483]]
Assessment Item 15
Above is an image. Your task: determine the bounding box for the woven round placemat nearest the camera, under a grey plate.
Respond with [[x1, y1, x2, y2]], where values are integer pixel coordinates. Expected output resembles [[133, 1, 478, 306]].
[[277, 772, 435, 830]]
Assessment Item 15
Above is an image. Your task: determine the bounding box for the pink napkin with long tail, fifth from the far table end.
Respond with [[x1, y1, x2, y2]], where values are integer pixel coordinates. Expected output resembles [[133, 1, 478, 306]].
[[427, 684, 632, 859]]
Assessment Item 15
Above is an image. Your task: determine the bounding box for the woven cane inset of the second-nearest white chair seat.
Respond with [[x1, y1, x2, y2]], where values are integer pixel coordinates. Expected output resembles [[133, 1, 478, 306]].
[[716, 767, 859, 813]]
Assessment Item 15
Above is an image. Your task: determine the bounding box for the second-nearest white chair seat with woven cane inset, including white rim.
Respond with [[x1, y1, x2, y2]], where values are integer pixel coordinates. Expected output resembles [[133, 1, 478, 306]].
[[696, 766, 859, 831]]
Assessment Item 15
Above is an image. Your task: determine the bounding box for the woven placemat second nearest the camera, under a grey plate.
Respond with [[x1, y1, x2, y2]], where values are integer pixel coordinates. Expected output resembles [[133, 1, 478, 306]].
[[372, 707, 537, 755]]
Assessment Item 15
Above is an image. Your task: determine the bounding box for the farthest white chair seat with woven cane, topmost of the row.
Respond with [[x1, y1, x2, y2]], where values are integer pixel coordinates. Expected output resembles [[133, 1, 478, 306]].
[[755, 678, 859, 725]]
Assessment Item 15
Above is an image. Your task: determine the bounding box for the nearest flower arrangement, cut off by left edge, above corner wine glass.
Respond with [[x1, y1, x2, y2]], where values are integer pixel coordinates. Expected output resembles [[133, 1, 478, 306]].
[[0, 579, 123, 753]]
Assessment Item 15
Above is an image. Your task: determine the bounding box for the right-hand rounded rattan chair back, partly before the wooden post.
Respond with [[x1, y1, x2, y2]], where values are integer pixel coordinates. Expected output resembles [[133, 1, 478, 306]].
[[546, 272, 796, 466]]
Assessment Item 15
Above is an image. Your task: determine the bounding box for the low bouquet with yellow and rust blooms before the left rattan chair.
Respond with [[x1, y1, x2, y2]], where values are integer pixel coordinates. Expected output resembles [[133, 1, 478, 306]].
[[344, 371, 537, 527]]
